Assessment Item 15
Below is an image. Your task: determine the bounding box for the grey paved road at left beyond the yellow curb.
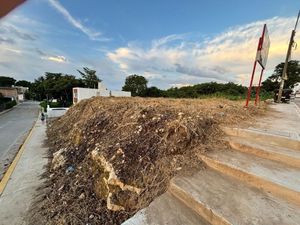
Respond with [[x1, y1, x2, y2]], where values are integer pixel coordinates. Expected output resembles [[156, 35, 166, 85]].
[[0, 102, 39, 179]]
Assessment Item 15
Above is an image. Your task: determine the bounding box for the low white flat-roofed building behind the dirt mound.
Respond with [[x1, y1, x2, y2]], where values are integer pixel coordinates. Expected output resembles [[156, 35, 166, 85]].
[[73, 82, 131, 104]]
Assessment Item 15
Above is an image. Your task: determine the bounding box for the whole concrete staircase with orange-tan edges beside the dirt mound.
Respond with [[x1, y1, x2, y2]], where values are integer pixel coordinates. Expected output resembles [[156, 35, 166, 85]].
[[123, 128, 300, 225]]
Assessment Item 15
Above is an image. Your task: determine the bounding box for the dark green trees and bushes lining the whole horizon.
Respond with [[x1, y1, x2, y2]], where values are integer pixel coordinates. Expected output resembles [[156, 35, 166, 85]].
[[0, 60, 300, 108]]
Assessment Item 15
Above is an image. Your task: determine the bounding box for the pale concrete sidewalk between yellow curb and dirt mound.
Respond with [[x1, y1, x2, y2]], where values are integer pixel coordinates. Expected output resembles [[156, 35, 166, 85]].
[[0, 121, 48, 225]]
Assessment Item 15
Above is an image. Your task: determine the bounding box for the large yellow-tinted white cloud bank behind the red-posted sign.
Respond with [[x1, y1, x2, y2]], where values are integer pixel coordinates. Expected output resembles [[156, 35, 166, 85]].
[[107, 17, 300, 87]]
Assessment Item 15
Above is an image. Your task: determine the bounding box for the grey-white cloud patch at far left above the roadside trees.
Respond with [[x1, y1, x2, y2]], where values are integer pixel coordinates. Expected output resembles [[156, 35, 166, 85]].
[[0, 15, 74, 81]]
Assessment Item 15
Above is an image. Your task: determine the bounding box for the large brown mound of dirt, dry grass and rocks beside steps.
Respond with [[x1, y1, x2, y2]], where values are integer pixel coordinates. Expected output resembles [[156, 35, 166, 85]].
[[31, 97, 264, 224]]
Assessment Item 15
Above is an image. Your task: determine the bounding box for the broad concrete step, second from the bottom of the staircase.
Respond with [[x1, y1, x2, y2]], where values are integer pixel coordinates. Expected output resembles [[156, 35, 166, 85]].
[[169, 169, 300, 225]]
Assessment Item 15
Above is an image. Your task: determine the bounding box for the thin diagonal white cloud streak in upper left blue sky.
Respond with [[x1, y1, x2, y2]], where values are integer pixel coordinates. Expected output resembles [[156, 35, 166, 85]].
[[48, 0, 109, 41]]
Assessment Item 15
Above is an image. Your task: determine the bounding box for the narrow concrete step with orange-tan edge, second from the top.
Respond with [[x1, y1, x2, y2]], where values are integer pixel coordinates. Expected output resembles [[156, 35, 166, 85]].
[[226, 137, 300, 168]]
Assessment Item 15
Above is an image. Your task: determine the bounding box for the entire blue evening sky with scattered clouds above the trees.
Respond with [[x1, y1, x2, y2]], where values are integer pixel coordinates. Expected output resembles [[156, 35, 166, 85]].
[[0, 0, 300, 90]]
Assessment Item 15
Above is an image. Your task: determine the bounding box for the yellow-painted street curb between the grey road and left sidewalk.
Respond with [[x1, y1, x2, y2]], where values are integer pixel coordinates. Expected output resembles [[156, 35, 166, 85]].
[[0, 119, 38, 196]]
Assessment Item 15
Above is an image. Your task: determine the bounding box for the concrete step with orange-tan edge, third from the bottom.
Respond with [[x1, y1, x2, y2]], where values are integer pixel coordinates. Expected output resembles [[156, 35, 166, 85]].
[[199, 150, 300, 205]]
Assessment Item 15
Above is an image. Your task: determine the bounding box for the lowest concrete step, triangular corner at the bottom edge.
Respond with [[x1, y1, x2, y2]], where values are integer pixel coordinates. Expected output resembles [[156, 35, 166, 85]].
[[122, 192, 209, 225]]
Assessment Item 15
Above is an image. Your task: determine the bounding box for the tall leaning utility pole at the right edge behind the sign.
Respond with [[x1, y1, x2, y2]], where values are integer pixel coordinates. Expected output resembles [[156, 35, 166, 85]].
[[277, 10, 300, 103]]
